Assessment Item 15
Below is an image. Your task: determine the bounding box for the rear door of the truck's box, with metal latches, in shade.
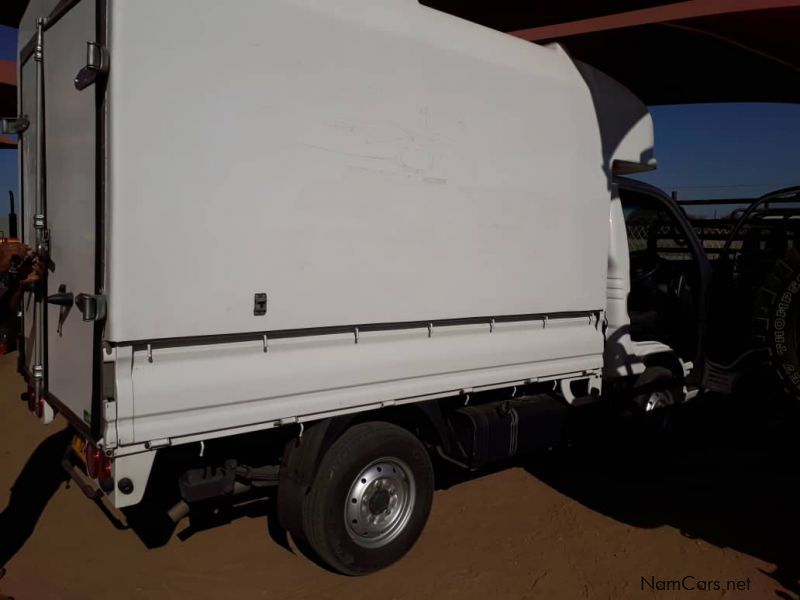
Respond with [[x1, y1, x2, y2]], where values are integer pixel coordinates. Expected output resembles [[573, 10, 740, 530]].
[[22, 0, 103, 437]]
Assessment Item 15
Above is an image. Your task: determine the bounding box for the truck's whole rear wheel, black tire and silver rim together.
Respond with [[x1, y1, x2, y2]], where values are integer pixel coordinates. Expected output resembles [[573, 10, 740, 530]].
[[302, 422, 433, 575]]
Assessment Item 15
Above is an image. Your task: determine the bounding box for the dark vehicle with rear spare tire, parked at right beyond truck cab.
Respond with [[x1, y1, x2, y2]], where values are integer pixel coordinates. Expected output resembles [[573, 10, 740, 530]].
[[668, 187, 800, 399]]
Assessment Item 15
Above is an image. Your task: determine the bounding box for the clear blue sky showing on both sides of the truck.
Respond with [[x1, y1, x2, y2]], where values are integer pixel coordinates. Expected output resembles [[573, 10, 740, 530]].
[[0, 22, 800, 229]]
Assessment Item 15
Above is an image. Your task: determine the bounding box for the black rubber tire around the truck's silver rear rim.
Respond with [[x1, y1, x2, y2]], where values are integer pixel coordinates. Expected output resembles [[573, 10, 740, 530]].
[[302, 422, 434, 575]]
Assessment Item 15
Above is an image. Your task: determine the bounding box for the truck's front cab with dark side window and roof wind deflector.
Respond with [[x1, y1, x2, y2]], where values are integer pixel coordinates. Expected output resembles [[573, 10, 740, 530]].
[[576, 61, 711, 404]]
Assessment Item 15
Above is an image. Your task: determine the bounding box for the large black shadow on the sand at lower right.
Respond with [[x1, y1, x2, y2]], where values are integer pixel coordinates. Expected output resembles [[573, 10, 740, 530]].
[[526, 389, 800, 600]]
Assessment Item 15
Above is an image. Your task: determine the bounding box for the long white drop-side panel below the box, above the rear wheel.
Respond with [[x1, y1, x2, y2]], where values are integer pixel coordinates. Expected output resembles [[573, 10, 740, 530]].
[[130, 317, 603, 443]]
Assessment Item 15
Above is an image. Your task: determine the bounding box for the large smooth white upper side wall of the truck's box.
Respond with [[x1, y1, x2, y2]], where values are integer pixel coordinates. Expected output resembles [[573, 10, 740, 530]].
[[107, 0, 609, 342]]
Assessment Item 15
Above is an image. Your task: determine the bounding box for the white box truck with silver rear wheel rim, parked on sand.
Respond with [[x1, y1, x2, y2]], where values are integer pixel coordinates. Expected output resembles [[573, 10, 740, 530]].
[[4, 0, 707, 574]]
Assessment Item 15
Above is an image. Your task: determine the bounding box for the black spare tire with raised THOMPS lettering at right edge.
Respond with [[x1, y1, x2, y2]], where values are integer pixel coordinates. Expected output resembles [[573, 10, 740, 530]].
[[753, 248, 800, 399]]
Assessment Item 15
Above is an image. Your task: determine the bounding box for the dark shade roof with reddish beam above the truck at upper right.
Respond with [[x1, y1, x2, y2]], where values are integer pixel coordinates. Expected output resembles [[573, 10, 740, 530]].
[[423, 0, 800, 105]]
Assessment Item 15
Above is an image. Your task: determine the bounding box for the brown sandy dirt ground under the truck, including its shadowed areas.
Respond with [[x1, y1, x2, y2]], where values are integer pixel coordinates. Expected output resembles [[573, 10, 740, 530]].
[[0, 355, 800, 600]]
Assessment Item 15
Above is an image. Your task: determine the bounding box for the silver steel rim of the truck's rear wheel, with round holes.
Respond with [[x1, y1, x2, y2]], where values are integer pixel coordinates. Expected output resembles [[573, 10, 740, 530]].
[[344, 458, 416, 548]]
